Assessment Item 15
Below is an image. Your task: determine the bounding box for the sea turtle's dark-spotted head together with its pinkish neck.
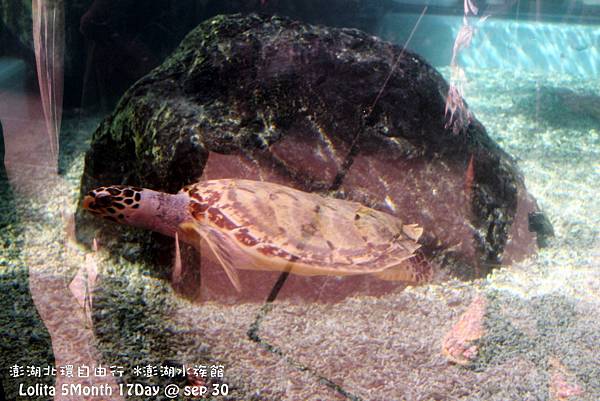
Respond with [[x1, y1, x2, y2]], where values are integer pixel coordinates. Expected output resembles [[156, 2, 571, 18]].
[[83, 185, 189, 236]]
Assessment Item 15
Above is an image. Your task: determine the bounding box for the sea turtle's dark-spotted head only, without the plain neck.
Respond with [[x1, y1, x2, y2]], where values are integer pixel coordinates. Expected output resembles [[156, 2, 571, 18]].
[[83, 185, 145, 225]]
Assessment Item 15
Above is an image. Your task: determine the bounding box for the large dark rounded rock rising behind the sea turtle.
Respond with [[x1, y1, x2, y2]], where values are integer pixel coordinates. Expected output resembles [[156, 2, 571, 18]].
[[80, 15, 538, 298]]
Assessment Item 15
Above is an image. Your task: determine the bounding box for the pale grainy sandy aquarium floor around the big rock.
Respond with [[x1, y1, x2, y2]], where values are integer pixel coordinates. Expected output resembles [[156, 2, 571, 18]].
[[0, 70, 600, 400]]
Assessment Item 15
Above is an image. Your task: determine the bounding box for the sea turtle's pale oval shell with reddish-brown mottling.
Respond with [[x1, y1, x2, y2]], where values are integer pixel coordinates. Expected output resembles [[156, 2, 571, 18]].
[[183, 179, 422, 288]]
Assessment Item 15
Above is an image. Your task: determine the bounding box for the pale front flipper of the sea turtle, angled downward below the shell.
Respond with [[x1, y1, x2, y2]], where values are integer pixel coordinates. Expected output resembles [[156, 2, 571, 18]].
[[179, 222, 253, 292]]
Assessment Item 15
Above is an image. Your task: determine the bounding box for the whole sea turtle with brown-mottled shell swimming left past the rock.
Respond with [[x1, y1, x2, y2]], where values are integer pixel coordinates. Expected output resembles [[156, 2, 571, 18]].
[[83, 179, 431, 291]]
